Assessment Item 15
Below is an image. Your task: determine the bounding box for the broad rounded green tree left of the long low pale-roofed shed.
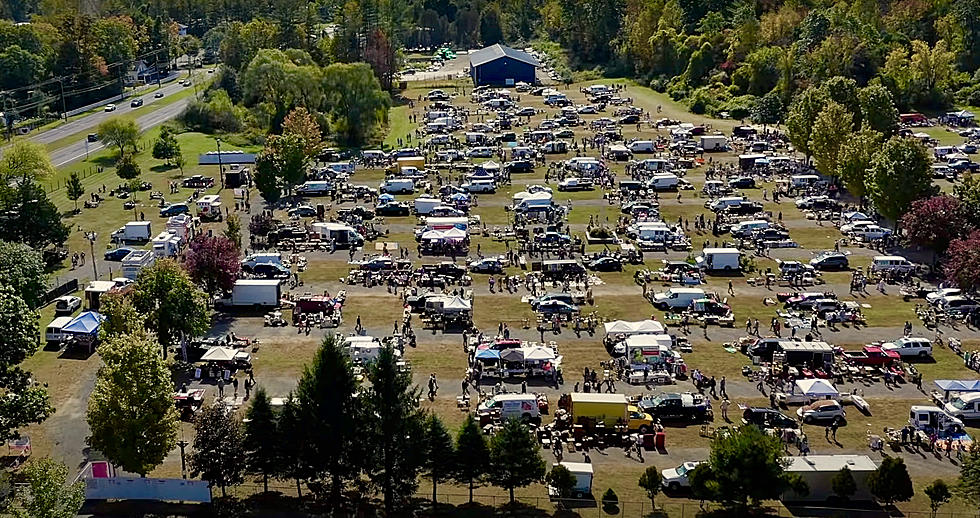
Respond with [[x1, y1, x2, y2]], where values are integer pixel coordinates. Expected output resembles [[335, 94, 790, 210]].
[[676, 426, 809, 515]]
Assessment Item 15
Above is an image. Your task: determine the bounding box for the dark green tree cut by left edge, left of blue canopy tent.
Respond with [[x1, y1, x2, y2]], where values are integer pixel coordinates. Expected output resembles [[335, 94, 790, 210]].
[[0, 284, 54, 442]]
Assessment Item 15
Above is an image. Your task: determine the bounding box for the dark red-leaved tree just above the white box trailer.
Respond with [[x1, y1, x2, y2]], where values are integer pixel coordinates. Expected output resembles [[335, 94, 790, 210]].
[[184, 233, 241, 297]]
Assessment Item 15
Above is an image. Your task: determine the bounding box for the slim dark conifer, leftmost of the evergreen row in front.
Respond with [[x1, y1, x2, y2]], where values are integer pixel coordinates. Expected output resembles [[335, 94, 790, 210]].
[[244, 387, 280, 492]]
